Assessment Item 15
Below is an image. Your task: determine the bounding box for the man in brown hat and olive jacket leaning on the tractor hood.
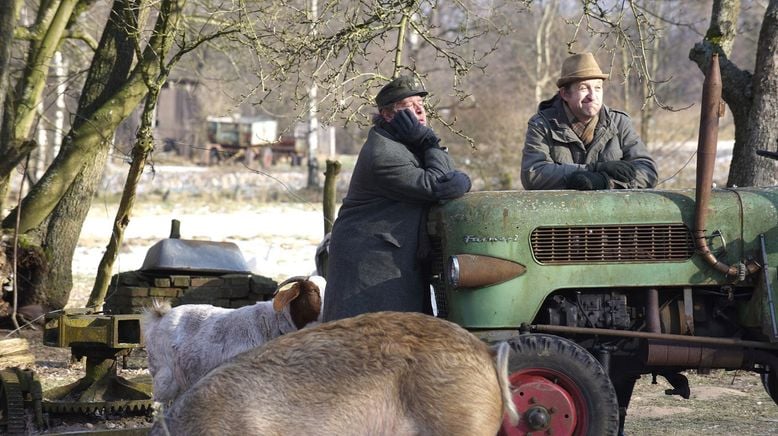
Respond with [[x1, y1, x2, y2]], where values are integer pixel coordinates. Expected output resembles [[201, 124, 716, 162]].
[[521, 53, 657, 190]]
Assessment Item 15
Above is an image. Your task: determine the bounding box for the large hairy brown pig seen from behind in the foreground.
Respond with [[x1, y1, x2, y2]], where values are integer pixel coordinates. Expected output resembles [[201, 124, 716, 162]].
[[150, 312, 519, 436]]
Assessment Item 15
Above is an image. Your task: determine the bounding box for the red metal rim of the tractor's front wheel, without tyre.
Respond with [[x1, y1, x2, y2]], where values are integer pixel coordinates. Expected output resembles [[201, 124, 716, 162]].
[[499, 368, 589, 436]]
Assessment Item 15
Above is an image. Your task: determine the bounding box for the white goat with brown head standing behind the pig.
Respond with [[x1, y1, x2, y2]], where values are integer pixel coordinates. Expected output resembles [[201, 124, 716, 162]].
[[142, 276, 324, 403]]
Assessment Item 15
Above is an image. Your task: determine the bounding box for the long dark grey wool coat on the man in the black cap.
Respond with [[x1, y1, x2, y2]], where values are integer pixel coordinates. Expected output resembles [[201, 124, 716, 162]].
[[322, 127, 454, 321]]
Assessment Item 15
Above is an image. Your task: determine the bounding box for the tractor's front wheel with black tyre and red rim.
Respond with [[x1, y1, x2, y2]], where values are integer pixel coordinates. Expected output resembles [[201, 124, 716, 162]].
[[500, 334, 619, 436]]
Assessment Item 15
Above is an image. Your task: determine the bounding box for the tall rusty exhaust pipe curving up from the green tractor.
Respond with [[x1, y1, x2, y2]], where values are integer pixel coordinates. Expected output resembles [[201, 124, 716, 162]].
[[692, 53, 760, 280]]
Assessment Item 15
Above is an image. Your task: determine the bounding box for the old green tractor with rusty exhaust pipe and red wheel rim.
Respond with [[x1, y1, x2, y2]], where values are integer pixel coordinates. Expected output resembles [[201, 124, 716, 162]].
[[428, 55, 778, 435]]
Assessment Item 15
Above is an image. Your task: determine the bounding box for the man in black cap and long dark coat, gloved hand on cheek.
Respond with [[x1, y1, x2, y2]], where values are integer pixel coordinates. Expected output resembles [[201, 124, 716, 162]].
[[322, 76, 470, 321]]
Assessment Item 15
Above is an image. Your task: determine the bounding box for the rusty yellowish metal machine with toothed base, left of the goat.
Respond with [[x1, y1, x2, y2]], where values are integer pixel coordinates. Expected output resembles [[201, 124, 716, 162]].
[[42, 309, 153, 413]]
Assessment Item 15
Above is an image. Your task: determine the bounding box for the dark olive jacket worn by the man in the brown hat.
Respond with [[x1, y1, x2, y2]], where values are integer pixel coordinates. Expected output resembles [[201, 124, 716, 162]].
[[521, 94, 657, 189]]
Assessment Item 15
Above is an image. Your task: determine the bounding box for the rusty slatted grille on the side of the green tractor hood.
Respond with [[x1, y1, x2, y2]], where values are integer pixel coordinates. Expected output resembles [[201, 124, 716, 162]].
[[530, 224, 694, 264]]
